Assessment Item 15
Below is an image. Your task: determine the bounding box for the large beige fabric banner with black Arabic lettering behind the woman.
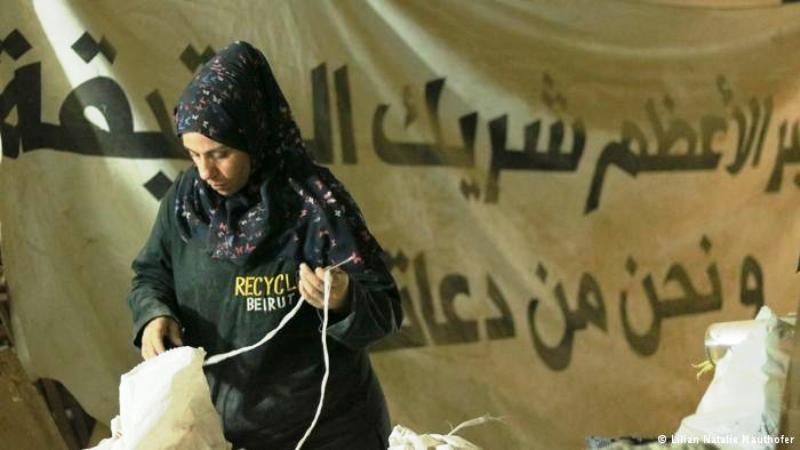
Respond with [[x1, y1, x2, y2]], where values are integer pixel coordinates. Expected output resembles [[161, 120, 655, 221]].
[[0, 0, 800, 449]]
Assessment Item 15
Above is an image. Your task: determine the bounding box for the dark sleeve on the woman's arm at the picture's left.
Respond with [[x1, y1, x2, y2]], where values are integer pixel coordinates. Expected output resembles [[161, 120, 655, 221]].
[[128, 184, 180, 347]]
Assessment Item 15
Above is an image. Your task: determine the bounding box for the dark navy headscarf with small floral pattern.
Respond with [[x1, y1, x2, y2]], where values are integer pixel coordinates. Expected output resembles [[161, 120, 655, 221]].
[[174, 41, 381, 265]]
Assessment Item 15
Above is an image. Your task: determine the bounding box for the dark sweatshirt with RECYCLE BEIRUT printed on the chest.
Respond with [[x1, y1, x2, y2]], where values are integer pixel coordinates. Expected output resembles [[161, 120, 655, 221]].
[[128, 178, 402, 450]]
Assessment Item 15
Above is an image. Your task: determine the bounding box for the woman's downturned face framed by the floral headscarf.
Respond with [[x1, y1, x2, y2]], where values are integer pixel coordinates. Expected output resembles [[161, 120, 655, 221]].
[[181, 133, 250, 196]]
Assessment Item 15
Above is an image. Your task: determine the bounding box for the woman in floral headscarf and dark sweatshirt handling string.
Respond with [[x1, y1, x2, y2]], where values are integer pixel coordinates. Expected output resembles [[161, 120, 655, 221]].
[[128, 42, 402, 450]]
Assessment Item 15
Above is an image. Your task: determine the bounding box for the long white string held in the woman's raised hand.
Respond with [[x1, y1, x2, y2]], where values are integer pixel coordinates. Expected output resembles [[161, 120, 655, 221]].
[[203, 256, 353, 450]]
